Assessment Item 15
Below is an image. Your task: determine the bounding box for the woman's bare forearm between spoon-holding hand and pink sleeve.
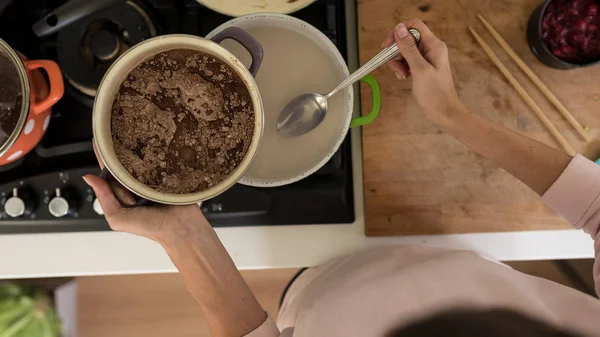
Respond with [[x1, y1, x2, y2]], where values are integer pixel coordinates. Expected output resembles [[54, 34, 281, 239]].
[[438, 106, 571, 195]]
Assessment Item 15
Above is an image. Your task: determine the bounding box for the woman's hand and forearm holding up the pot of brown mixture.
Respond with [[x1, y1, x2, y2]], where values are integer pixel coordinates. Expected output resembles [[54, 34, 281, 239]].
[[84, 175, 279, 337]]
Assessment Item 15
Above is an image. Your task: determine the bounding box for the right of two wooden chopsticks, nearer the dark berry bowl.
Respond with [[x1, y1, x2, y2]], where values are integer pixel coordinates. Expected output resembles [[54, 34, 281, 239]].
[[477, 14, 592, 142]]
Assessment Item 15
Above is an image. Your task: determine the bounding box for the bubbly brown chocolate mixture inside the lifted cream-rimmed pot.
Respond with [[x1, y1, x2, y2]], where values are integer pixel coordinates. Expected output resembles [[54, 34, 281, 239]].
[[111, 49, 254, 194]]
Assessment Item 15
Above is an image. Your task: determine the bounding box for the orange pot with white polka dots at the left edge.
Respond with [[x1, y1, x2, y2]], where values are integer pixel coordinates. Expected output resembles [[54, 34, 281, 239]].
[[0, 39, 64, 165]]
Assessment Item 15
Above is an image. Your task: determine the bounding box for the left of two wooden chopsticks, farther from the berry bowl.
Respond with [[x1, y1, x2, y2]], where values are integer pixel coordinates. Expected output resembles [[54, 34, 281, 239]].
[[469, 27, 576, 156]]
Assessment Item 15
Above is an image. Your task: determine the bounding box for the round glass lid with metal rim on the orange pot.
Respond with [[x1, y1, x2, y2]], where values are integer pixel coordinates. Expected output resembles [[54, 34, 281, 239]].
[[0, 39, 29, 156]]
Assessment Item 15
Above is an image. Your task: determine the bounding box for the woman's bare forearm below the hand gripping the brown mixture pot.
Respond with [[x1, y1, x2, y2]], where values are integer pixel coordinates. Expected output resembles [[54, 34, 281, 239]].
[[161, 211, 267, 337]]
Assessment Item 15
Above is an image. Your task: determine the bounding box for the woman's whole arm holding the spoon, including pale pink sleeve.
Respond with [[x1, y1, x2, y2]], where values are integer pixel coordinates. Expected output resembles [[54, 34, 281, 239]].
[[383, 19, 600, 294]]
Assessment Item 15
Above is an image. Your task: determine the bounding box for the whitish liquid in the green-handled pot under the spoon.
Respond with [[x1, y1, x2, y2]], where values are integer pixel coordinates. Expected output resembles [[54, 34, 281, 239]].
[[221, 27, 349, 182]]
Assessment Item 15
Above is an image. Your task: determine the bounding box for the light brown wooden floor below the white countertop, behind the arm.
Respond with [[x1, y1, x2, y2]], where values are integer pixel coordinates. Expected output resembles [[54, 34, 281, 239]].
[[77, 269, 298, 337]]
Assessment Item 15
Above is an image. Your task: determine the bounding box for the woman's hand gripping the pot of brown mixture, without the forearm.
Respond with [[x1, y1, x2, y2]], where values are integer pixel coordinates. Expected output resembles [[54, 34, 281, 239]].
[[83, 147, 205, 246]]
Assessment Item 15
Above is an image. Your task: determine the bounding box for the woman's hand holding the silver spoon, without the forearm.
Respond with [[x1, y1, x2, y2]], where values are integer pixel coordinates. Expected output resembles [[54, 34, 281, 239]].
[[382, 19, 464, 123]]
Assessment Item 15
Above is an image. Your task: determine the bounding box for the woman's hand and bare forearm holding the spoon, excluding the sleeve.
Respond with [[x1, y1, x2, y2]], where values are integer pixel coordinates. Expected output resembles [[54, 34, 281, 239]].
[[384, 19, 571, 195]]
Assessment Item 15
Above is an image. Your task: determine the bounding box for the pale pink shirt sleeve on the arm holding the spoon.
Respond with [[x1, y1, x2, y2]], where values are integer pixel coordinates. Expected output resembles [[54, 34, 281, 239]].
[[542, 154, 600, 295]]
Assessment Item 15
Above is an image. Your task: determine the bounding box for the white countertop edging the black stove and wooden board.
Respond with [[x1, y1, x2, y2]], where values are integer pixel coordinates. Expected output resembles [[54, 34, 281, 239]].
[[0, 129, 594, 279]]
